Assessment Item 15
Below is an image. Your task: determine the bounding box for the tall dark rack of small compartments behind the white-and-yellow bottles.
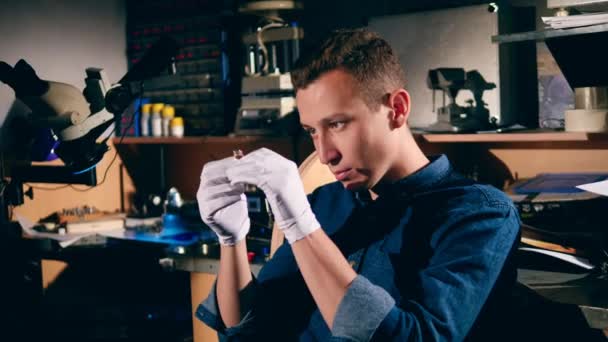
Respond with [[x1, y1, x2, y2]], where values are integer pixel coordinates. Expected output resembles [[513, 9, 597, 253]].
[[123, 0, 233, 136]]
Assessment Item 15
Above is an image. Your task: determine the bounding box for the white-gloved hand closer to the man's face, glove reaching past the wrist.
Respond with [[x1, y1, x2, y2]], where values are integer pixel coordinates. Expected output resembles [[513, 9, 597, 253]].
[[226, 148, 321, 243]]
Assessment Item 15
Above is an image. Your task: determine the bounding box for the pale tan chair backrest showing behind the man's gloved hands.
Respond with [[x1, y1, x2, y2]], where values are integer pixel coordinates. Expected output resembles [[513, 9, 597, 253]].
[[270, 151, 336, 256]]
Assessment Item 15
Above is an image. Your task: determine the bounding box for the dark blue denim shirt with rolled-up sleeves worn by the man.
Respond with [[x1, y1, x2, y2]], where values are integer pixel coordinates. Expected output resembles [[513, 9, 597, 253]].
[[196, 156, 520, 341]]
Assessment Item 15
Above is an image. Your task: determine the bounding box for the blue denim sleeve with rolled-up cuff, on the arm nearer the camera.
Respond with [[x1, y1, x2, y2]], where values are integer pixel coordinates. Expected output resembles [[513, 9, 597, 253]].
[[331, 205, 519, 341]]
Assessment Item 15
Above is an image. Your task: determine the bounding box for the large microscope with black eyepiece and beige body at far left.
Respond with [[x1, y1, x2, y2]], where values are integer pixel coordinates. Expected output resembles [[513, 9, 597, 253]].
[[0, 37, 179, 219]]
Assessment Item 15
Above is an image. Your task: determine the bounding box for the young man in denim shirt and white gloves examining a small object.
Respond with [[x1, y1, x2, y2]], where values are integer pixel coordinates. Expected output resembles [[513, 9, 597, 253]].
[[197, 29, 519, 341]]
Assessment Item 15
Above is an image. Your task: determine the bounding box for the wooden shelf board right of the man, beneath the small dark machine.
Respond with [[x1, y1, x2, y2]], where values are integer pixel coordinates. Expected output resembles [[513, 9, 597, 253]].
[[417, 131, 608, 143]]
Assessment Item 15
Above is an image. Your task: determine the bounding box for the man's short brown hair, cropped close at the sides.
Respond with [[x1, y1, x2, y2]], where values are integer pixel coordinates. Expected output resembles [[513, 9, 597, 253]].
[[291, 29, 405, 109]]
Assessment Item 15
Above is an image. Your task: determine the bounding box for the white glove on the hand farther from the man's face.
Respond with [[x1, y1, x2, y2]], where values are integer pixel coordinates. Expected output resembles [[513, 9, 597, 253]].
[[196, 157, 250, 246]]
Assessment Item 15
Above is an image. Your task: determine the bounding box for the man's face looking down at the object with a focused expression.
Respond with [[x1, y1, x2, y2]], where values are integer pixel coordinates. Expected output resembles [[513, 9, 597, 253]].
[[296, 70, 397, 190]]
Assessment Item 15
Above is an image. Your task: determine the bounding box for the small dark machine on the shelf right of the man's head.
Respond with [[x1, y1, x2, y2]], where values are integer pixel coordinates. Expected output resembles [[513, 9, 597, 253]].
[[425, 68, 496, 133]]
